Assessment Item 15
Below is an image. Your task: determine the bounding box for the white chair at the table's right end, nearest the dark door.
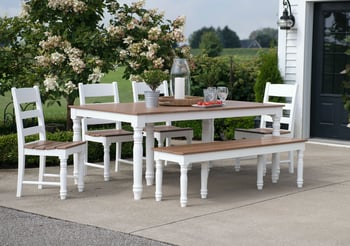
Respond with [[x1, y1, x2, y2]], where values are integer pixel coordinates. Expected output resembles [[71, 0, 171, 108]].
[[235, 82, 298, 173]]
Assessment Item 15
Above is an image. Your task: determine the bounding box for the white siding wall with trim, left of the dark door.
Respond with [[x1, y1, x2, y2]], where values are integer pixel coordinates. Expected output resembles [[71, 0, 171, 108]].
[[278, 0, 349, 138]]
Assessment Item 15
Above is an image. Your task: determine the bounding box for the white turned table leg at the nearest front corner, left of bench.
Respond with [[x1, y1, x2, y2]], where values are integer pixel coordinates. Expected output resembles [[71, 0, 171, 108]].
[[133, 126, 143, 200]]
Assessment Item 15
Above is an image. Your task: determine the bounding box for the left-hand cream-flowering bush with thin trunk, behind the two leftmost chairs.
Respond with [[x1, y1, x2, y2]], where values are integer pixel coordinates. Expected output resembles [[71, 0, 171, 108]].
[[13, 0, 116, 128]]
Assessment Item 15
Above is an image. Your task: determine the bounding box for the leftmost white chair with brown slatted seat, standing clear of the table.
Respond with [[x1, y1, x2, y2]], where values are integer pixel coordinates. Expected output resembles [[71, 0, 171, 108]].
[[11, 86, 86, 199]]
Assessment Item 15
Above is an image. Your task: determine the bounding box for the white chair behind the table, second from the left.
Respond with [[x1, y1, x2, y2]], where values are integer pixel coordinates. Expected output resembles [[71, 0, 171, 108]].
[[79, 82, 133, 181]]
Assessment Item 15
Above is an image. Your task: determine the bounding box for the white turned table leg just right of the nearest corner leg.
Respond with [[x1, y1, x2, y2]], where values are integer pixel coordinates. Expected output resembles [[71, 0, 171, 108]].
[[145, 123, 154, 185]]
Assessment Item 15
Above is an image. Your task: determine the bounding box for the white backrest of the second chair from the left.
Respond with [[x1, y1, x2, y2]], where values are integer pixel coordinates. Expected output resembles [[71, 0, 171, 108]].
[[78, 82, 121, 134]]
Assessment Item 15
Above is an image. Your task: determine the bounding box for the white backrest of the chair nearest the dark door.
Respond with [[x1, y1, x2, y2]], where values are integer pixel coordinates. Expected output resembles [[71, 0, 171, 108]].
[[260, 82, 298, 136]]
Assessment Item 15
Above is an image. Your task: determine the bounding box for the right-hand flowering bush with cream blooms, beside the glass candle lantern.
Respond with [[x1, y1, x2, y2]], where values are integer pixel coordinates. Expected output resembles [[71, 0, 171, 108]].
[[107, 0, 190, 83]]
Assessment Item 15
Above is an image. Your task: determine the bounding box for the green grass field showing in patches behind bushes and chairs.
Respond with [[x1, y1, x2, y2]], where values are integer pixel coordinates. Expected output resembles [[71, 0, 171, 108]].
[[0, 49, 262, 124]]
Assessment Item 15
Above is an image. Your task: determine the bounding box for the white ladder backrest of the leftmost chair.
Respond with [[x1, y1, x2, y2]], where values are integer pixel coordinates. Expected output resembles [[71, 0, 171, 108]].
[[11, 86, 46, 151]]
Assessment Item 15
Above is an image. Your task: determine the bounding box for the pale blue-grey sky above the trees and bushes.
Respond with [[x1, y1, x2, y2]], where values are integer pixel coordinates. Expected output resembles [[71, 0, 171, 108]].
[[0, 0, 279, 39]]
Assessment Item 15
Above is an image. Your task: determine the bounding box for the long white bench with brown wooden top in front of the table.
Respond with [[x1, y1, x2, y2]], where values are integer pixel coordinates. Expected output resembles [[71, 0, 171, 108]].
[[154, 137, 306, 207]]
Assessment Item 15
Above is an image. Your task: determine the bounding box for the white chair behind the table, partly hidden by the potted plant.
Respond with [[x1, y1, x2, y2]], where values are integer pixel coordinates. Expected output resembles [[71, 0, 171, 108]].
[[132, 80, 193, 147]]
